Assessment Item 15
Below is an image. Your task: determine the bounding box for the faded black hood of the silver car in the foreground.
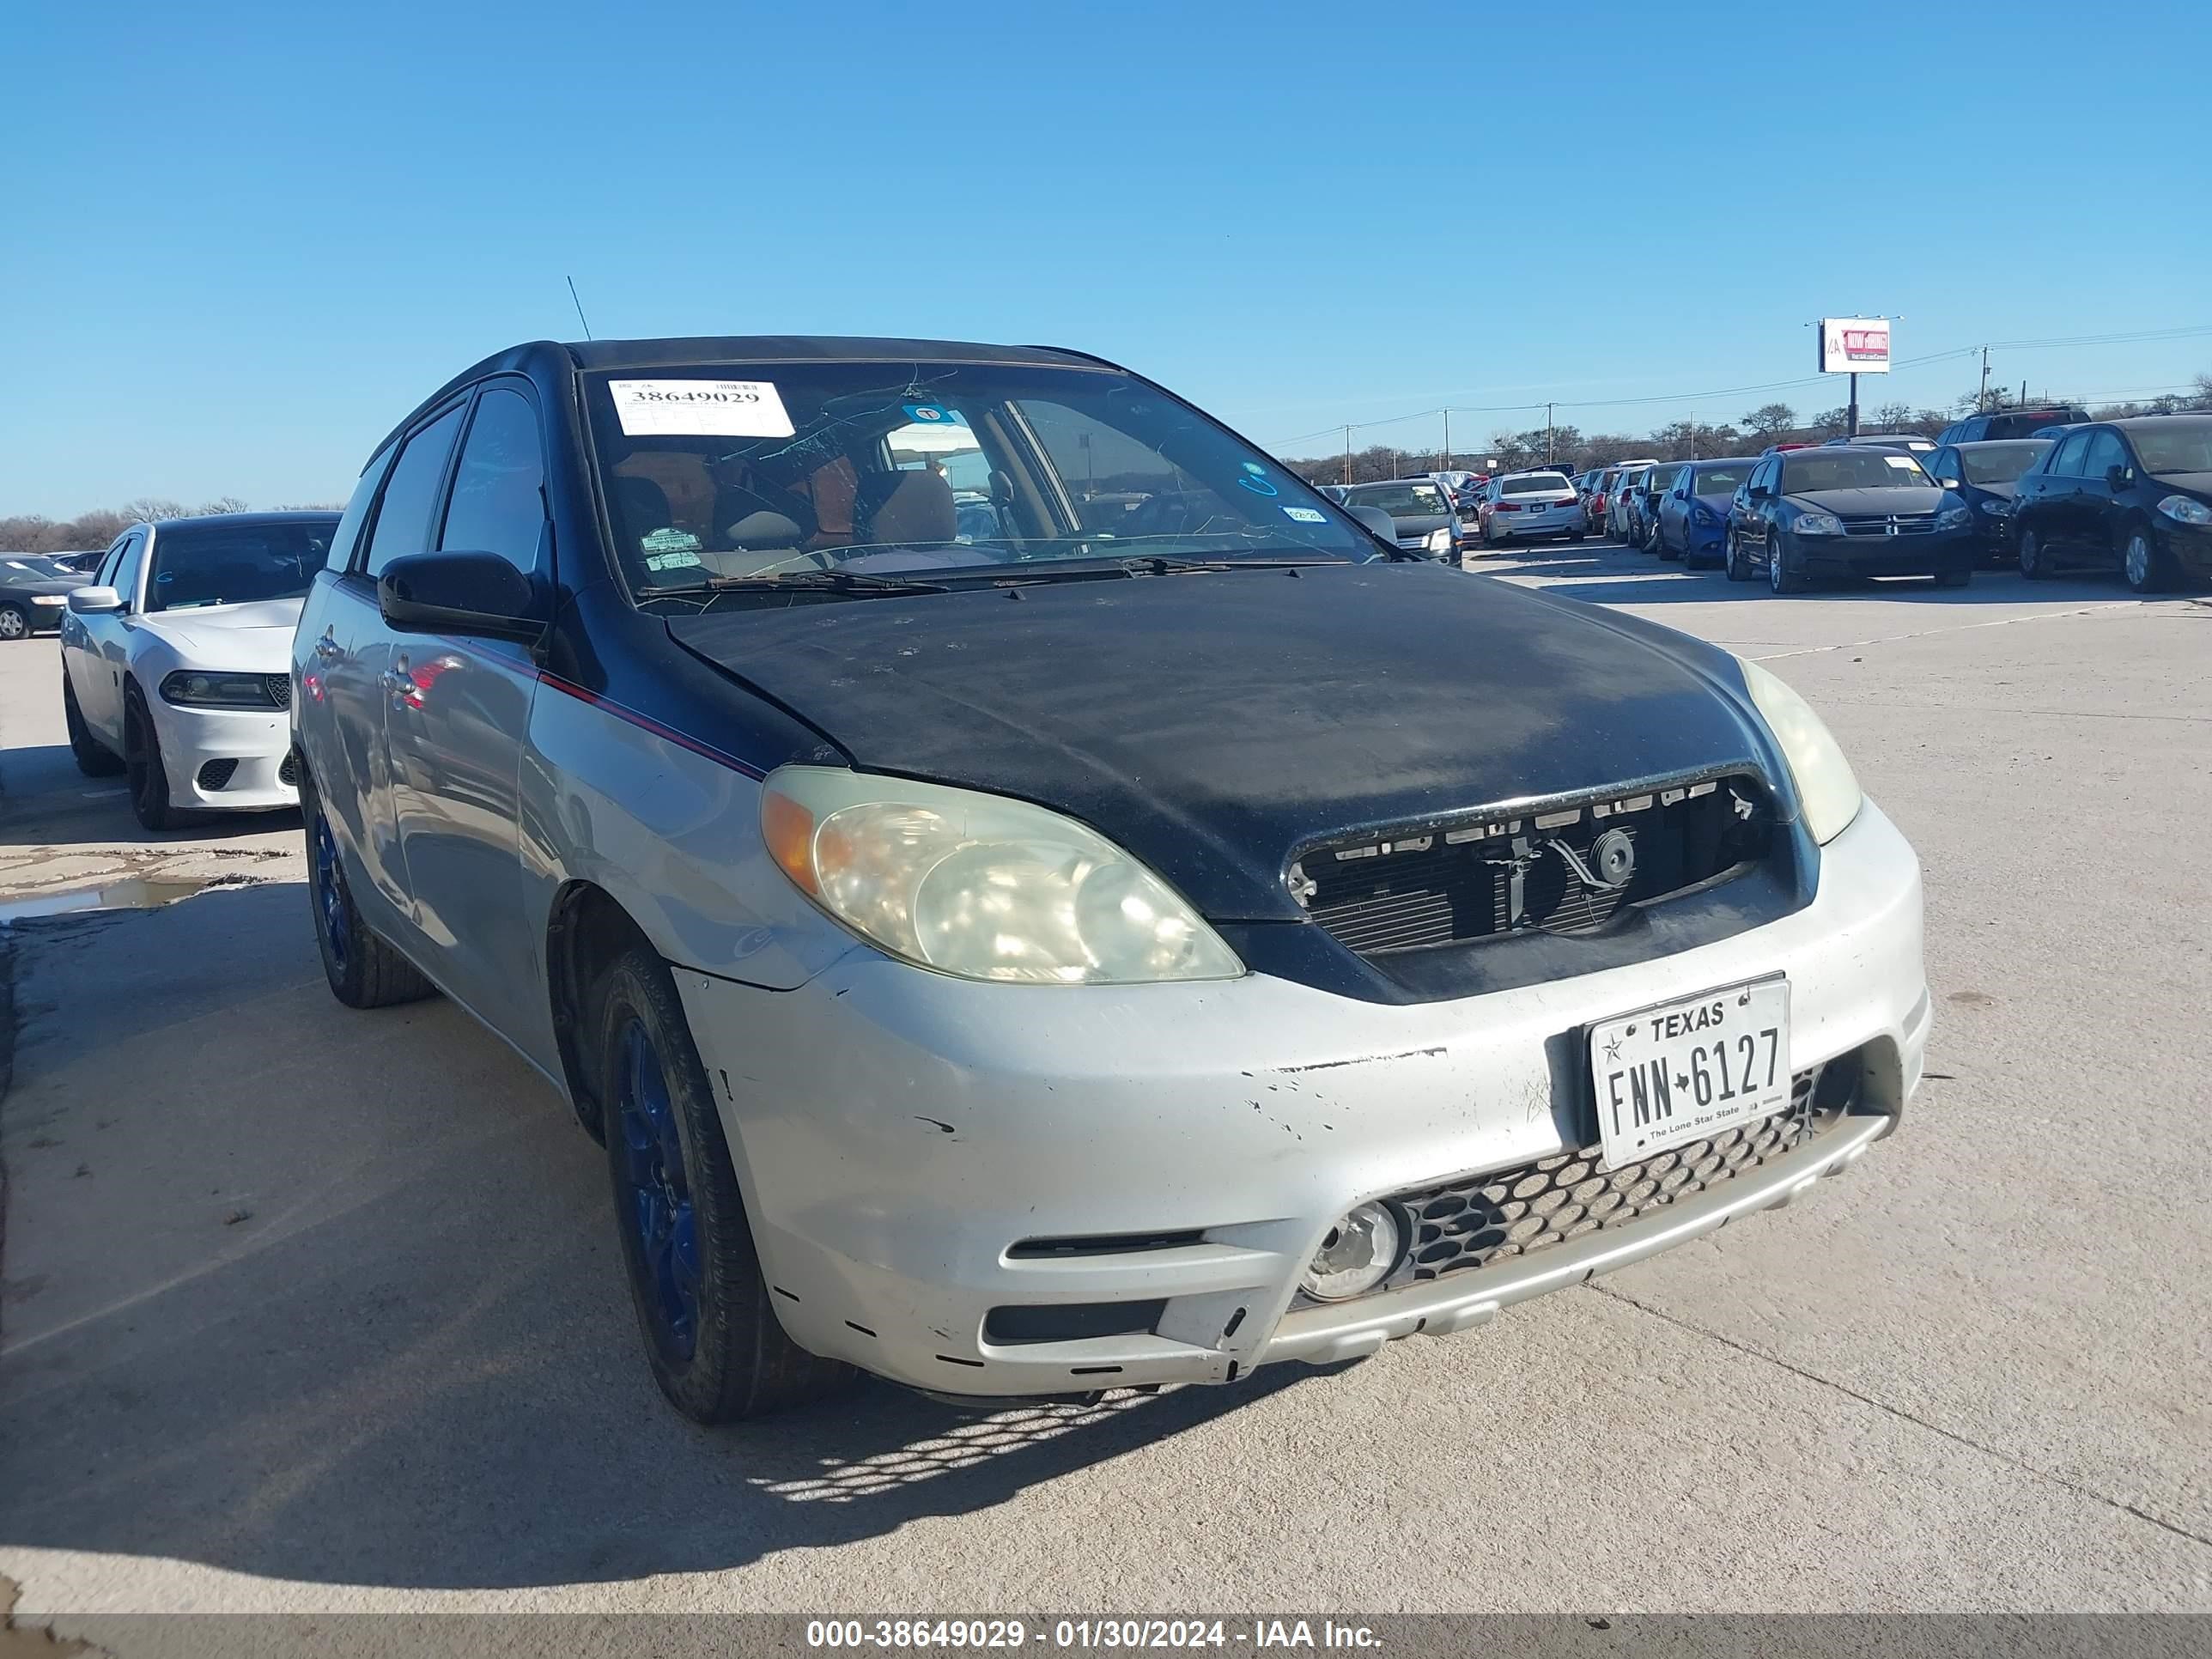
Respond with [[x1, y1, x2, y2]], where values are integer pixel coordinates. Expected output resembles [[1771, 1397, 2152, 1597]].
[[668, 564, 1790, 921]]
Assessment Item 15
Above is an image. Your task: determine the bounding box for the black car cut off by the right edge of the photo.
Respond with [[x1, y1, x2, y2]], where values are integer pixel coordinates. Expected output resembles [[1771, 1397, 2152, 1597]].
[[2011, 416, 2212, 592]]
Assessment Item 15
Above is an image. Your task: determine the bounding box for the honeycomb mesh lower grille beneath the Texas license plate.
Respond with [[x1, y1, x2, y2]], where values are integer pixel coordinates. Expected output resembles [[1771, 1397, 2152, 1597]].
[[1382, 1057, 1858, 1287]]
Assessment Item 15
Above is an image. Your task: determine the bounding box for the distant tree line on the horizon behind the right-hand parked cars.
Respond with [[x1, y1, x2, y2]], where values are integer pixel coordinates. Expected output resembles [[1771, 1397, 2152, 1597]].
[[1283, 374, 2212, 484]]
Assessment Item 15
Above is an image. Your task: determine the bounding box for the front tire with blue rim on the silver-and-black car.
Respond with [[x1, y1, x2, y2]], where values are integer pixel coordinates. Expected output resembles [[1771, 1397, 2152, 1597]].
[[592, 945, 856, 1422]]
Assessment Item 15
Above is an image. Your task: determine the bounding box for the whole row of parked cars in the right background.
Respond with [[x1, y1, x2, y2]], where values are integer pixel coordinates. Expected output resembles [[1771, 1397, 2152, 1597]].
[[1328, 407, 2212, 592]]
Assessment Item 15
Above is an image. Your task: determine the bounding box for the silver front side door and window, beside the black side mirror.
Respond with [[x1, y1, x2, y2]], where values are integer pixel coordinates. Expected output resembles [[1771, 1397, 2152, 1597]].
[[385, 378, 553, 1036]]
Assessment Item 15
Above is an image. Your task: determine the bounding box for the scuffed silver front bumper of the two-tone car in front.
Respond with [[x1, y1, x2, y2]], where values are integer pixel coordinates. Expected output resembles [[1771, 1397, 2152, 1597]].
[[677, 803, 1929, 1395]]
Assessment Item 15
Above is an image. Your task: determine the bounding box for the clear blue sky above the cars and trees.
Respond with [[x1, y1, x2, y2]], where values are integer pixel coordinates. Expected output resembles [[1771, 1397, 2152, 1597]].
[[0, 0, 2212, 518]]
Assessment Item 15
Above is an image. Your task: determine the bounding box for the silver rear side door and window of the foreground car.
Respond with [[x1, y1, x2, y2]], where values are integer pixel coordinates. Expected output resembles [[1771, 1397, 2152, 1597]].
[[323, 396, 469, 928]]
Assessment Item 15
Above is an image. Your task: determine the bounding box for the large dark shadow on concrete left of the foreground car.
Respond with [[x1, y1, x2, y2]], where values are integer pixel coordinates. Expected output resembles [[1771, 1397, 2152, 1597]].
[[0, 883, 1314, 1589]]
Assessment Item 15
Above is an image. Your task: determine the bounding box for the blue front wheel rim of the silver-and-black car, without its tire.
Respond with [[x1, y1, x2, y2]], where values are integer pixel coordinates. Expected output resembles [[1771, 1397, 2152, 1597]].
[[615, 1013, 702, 1360]]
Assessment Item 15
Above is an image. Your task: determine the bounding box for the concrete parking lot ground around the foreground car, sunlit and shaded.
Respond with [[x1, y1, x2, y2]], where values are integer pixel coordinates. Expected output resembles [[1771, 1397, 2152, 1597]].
[[0, 544, 2212, 1631]]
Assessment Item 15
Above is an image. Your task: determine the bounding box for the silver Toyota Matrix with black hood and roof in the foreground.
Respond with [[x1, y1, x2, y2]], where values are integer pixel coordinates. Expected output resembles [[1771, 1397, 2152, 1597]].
[[289, 338, 1929, 1422]]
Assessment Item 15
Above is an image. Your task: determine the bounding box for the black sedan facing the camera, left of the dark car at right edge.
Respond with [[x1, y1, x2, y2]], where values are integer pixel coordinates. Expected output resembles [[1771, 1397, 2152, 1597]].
[[1728, 447, 1973, 592]]
